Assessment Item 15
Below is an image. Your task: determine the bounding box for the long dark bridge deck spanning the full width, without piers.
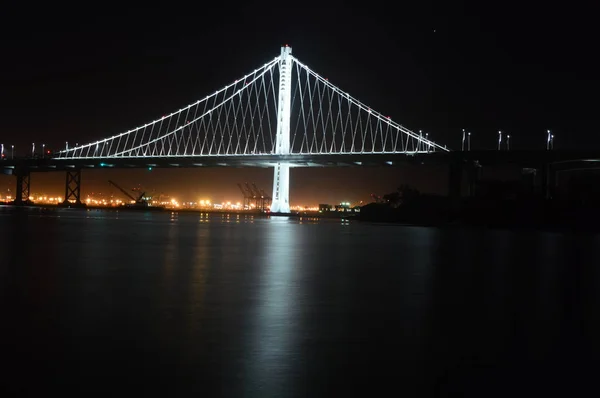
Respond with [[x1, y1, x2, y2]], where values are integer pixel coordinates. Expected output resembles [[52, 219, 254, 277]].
[[0, 150, 600, 174]]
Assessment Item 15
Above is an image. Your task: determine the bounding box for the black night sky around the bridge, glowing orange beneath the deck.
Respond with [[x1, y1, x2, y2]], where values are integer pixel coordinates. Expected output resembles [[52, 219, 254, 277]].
[[0, 1, 600, 203]]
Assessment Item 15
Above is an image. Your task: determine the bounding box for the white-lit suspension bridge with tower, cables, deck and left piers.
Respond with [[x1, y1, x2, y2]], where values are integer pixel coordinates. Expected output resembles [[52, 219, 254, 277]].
[[2, 45, 448, 213]]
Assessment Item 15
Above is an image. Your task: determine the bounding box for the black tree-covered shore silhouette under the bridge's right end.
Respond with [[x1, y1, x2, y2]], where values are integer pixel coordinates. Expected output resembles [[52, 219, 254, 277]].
[[357, 172, 600, 230]]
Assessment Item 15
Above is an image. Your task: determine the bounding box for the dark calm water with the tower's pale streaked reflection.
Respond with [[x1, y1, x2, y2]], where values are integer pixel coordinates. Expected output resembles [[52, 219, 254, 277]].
[[0, 209, 600, 396]]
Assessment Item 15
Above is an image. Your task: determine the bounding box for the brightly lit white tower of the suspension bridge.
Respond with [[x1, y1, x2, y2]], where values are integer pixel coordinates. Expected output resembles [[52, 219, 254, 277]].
[[271, 45, 294, 213]]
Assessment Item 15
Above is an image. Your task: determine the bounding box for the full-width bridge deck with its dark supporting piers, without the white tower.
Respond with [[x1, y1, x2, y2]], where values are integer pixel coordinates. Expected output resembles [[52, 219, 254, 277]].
[[0, 150, 600, 206]]
